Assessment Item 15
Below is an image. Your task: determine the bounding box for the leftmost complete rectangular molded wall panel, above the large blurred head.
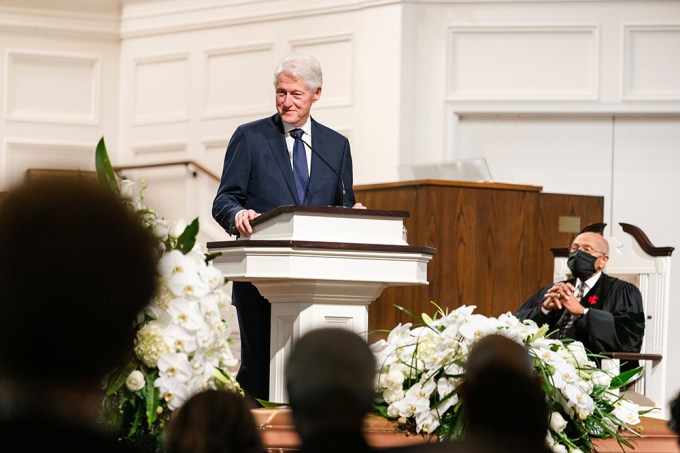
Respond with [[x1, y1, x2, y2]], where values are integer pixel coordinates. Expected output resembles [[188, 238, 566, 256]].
[[4, 49, 102, 125]]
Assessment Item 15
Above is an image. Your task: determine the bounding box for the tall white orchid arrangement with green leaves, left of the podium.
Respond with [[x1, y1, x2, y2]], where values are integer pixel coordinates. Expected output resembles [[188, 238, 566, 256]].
[[96, 139, 242, 451]]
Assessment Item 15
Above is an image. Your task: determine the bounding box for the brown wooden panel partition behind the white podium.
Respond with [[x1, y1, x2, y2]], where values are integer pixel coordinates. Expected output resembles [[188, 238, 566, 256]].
[[354, 181, 604, 336]]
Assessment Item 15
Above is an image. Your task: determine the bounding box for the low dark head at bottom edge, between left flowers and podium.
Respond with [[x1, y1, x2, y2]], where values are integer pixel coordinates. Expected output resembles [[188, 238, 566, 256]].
[[165, 390, 264, 453]]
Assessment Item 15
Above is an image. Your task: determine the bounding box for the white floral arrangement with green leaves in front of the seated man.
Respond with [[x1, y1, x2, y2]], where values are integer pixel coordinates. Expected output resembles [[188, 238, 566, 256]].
[[371, 306, 641, 453]]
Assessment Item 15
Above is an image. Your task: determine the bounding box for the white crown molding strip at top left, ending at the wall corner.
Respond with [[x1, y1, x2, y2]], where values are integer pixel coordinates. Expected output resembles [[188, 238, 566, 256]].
[[0, 6, 120, 40]]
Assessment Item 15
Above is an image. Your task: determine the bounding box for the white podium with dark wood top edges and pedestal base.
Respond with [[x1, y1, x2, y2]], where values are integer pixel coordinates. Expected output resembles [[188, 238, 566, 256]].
[[208, 206, 436, 403]]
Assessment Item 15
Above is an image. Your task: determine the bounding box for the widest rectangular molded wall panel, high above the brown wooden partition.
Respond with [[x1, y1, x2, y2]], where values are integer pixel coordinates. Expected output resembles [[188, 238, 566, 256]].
[[445, 24, 599, 101]]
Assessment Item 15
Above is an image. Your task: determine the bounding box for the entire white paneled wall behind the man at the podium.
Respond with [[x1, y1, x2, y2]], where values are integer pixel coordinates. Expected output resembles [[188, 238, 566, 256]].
[[0, 0, 680, 416]]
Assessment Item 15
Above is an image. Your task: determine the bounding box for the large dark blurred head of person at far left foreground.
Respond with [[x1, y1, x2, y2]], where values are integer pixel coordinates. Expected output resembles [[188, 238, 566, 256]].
[[0, 176, 157, 453]]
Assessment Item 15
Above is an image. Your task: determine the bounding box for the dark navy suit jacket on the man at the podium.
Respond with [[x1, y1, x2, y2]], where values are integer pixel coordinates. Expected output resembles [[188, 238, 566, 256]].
[[212, 114, 355, 232]]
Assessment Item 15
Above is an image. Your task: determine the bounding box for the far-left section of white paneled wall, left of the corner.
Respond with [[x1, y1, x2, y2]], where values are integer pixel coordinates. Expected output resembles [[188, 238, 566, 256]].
[[0, 0, 119, 190]]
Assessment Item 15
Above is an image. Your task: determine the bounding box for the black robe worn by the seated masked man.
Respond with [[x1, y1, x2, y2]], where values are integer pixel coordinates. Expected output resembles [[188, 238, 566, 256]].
[[515, 273, 645, 360]]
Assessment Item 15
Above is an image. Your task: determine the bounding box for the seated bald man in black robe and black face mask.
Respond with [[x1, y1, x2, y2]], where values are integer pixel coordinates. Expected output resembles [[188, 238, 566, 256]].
[[515, 232, 645, 369]]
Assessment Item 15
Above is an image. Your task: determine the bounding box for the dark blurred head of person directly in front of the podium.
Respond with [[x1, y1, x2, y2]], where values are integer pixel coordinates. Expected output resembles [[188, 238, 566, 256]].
[[286, 328, 375, 453]]
